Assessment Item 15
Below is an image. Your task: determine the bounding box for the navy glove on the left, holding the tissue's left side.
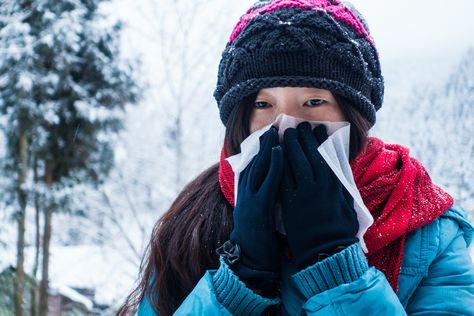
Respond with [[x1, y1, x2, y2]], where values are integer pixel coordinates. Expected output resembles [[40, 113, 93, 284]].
[[221, 127, 283, 287]]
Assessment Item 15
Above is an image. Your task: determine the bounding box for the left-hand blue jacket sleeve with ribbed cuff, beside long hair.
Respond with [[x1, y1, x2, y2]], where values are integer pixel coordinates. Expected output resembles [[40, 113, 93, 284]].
[[138, 258, 280, 316]]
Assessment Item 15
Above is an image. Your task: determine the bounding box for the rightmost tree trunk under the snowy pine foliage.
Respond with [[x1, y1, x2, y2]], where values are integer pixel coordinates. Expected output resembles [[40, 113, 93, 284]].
[[39, 159, 54, 316]]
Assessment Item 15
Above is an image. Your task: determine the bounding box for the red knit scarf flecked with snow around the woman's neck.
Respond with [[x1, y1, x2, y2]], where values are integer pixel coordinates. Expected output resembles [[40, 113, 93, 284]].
[[219, 137, 453, 292]]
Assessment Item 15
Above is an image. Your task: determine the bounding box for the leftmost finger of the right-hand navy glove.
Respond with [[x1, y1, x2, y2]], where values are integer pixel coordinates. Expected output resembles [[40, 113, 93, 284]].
[[283, 128, 313, 184]]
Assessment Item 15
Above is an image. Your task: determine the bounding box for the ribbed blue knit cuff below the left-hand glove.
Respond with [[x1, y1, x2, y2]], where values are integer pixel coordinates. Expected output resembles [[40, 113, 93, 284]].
[[213, 257, 280, 315]]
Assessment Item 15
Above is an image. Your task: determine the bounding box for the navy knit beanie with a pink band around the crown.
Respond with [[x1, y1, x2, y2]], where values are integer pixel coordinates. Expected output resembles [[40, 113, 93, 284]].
[[214, 0, 384, 125]]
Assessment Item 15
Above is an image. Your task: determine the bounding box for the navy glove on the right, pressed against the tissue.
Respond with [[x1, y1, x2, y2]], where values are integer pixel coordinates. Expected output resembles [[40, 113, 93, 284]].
[[281, 122, 359, 269]]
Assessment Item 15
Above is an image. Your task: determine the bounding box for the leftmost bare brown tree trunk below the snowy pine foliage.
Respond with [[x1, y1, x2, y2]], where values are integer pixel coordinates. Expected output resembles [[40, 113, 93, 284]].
[[15, 131, 28, 316]]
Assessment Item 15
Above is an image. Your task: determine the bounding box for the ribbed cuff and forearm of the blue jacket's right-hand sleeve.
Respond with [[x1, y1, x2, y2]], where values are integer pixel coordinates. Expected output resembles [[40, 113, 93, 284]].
[[292, 243, 406, 316]]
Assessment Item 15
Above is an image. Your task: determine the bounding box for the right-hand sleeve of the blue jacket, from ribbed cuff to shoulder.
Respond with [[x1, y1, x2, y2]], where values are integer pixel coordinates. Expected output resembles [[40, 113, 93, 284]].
[[292, 206, 474, 315]]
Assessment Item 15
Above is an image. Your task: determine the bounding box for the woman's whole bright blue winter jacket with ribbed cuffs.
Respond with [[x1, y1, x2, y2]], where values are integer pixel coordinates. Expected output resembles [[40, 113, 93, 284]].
[[138, 207, 474, 316]]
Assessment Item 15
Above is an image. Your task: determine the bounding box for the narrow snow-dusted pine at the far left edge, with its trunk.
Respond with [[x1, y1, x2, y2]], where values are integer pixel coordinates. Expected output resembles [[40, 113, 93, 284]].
[[0, 1, 34, 316]]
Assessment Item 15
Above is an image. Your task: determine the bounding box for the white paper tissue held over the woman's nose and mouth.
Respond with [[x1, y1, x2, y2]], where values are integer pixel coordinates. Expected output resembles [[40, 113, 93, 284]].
[[227, 114, 374, 253]]
